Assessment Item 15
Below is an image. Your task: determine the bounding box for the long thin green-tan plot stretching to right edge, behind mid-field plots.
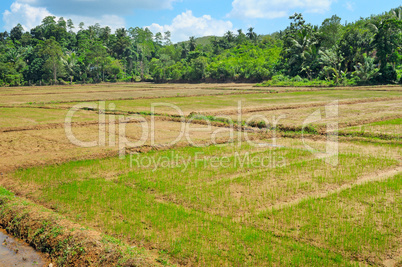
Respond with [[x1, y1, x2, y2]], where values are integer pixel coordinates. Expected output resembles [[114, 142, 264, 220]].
[[27, 90, 401, 115]]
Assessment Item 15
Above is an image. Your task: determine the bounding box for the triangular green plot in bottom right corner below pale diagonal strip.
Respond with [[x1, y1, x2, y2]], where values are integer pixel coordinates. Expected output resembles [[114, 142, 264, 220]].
[[253, 173, 402, 265]]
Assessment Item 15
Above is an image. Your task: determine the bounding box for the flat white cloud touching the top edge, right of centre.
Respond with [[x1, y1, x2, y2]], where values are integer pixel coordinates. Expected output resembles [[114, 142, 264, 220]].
[[228, 0, 334, 19]]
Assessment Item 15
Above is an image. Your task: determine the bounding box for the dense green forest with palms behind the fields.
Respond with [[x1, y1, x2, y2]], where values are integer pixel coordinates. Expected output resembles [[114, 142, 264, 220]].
[[0, 7, 402, 86]]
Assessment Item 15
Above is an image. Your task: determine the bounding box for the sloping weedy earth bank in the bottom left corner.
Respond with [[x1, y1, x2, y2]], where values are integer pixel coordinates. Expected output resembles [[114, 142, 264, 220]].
[[0, 187, 158, 267]]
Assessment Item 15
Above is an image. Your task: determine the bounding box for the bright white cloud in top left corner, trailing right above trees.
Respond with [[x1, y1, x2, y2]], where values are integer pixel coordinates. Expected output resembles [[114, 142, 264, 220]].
[[3, 0, 126, 31]]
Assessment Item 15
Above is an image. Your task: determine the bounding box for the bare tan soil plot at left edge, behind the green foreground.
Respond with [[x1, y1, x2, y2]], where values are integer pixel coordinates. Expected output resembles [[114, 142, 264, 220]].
[[0, 120, 234, 172]]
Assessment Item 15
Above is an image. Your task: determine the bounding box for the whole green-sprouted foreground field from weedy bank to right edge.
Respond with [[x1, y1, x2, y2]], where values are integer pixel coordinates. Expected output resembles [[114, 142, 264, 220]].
[[6, 140, 402, 265]]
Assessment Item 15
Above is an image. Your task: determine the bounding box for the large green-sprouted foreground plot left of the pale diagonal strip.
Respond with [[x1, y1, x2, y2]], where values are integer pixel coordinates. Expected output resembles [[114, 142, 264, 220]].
[[8, 140, 397, 266]]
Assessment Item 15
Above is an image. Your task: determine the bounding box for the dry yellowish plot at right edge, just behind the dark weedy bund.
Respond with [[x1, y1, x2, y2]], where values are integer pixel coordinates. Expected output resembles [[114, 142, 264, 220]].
[[220, 99, 402, 135]]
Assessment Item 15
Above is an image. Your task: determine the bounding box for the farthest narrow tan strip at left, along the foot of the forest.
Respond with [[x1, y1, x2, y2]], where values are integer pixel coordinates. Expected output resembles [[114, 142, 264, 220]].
[[0, 83, 260, 105]]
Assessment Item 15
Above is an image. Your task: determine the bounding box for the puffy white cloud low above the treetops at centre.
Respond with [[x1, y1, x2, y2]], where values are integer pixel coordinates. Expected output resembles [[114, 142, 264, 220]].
[[146, 10, 233, 42]]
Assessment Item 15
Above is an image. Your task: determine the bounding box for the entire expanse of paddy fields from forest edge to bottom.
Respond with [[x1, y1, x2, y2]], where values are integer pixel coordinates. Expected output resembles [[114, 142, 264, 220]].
[[0, 84, 402, 266]]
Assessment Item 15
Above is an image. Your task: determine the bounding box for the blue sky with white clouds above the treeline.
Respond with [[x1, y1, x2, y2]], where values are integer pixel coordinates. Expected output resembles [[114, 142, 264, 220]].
[[0, 0, 401, 42]]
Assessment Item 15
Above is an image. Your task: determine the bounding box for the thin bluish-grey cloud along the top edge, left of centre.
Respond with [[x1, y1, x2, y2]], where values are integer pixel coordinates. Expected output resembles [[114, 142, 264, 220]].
[[18, 0, 180, 17]]
